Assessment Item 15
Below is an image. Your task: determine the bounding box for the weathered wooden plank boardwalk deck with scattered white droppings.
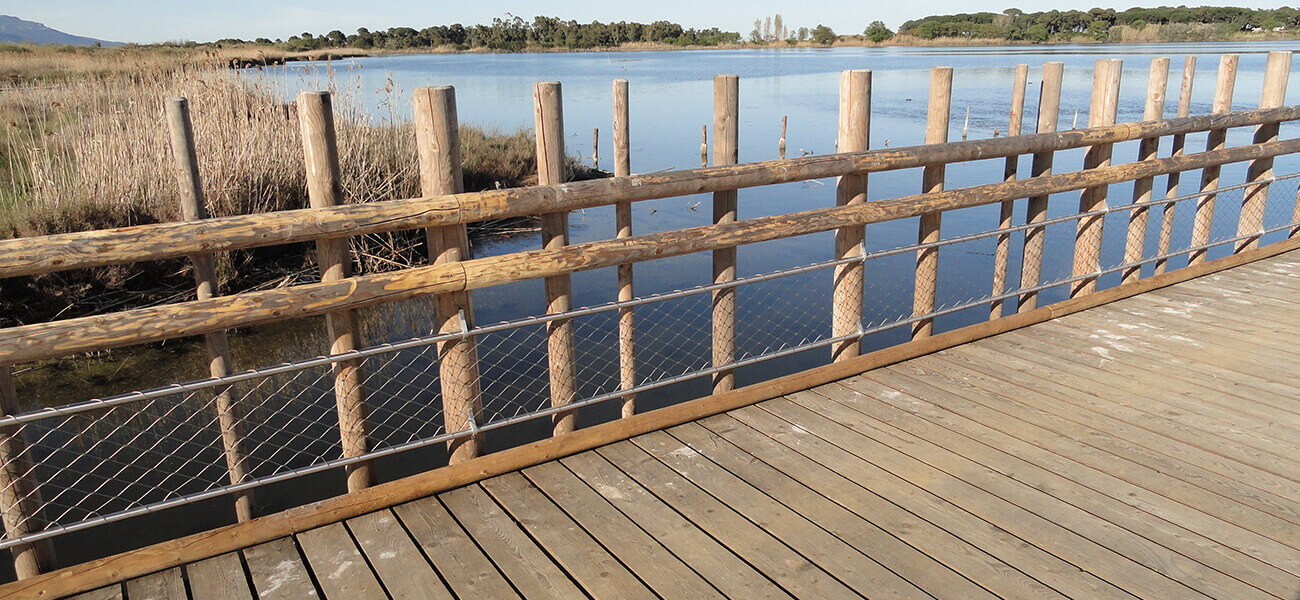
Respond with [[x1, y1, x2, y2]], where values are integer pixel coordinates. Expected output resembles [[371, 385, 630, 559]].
[[68, 252, 1300, 600]]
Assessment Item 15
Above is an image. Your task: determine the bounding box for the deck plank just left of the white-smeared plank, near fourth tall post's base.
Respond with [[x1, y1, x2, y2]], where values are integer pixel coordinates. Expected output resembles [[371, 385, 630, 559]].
[[523, 462, 723, 599]]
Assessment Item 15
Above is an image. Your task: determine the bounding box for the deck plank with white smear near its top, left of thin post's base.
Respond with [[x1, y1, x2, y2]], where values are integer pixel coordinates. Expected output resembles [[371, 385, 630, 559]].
[[560, 452, 790, 599]]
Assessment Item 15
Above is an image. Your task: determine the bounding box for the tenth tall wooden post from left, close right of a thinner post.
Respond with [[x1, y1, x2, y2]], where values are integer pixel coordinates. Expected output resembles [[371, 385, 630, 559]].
[[1015, 61, 1065, 313]]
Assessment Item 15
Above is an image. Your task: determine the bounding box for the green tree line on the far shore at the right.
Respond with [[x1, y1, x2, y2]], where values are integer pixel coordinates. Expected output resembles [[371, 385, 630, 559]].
[[898, 6, 1300, 42]]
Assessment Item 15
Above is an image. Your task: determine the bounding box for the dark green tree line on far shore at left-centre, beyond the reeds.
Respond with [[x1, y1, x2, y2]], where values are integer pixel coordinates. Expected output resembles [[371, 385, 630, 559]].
[[217, 14, 740, 52]]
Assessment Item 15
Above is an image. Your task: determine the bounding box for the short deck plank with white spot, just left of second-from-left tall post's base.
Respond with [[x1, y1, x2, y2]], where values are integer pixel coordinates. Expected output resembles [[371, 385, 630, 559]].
[[298, 523, 389, 600]]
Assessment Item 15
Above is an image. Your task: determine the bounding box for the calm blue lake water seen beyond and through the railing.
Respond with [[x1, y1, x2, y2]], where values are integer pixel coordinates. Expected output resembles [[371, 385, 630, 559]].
[[5, 43, 1300, 576]]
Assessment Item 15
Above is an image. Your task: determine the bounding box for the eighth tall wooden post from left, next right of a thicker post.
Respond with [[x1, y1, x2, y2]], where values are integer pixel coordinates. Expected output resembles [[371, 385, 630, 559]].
[[911, 66, 953, 339]]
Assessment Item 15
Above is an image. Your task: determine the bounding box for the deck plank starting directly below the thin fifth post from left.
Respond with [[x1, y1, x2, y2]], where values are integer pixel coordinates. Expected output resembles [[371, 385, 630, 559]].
[[595, 442, 862, 599]]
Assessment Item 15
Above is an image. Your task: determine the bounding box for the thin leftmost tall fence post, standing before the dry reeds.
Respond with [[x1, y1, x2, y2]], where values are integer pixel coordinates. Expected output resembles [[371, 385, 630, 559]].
[[166, 97, 254, 522]]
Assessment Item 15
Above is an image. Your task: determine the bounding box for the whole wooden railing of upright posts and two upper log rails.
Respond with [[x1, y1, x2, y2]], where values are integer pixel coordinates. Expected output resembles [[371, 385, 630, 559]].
[[0, 52, 1300, 577]]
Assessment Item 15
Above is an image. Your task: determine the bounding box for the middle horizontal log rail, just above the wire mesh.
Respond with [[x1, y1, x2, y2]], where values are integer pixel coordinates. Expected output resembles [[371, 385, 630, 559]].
[[0, 139, 1300, 365]]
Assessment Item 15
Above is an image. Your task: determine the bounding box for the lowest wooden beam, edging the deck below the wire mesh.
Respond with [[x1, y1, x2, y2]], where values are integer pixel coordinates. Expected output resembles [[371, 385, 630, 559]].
[[0, 233, 1300, 600]]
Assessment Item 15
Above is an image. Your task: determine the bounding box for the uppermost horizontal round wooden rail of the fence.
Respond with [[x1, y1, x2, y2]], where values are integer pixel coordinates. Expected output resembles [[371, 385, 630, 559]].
[[0, 105, 1300, 278]]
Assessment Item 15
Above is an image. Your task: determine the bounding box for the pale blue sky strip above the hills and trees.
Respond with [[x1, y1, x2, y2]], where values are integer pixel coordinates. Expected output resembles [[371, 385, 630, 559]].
[[10, 0, 1294, 43]]
